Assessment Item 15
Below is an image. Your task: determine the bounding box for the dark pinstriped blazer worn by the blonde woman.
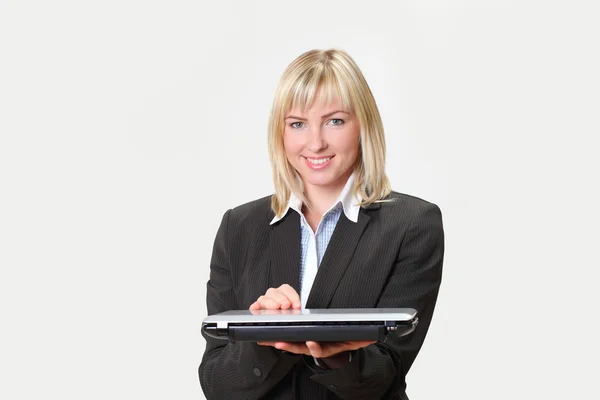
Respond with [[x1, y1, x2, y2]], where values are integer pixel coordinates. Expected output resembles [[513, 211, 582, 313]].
[[198, 192, 444, 400]]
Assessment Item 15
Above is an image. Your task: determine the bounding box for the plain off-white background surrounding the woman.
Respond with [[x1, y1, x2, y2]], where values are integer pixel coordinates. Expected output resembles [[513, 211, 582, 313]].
[[0, 0, 600, 399]]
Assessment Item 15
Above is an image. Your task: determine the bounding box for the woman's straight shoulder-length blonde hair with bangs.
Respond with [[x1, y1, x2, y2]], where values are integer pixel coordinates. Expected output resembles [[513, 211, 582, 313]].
[[268, 49, 391, 217]]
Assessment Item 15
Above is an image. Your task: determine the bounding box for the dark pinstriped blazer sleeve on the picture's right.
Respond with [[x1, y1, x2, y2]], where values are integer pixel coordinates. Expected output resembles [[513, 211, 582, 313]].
[[306, 203, 444, 399]]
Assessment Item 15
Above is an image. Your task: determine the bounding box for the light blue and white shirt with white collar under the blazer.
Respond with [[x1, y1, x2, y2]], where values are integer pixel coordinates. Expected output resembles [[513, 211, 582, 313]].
[[271, 174, 360, 308]]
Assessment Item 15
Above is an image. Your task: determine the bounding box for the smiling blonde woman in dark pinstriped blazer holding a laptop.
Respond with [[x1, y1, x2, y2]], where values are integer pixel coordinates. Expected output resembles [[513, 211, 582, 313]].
[[199, 50, 444, 400]]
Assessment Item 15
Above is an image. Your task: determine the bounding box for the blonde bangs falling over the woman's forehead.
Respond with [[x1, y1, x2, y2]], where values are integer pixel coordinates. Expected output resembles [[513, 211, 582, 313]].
[[283, 64, 354, 114]]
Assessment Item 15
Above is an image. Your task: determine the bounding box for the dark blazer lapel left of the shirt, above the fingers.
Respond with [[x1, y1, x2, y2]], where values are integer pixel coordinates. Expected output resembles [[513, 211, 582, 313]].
[[270, 210, 300, 293]]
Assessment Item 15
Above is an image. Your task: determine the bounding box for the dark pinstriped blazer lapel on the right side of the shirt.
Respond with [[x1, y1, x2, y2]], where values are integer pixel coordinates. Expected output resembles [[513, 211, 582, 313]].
[[306, 207, 378, 308]]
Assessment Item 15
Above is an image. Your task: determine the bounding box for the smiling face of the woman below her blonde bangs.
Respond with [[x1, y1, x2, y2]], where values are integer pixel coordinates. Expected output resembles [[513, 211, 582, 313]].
[[283, 99, 360, 194]]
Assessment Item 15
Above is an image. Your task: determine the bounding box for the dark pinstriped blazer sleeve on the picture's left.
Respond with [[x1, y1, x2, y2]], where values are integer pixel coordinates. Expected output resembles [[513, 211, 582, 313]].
[[198, 210, 301, 400]]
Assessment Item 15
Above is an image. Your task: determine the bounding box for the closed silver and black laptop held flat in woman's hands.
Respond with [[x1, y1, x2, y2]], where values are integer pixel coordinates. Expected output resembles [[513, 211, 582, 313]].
[[202, 308, 418, 342]]
